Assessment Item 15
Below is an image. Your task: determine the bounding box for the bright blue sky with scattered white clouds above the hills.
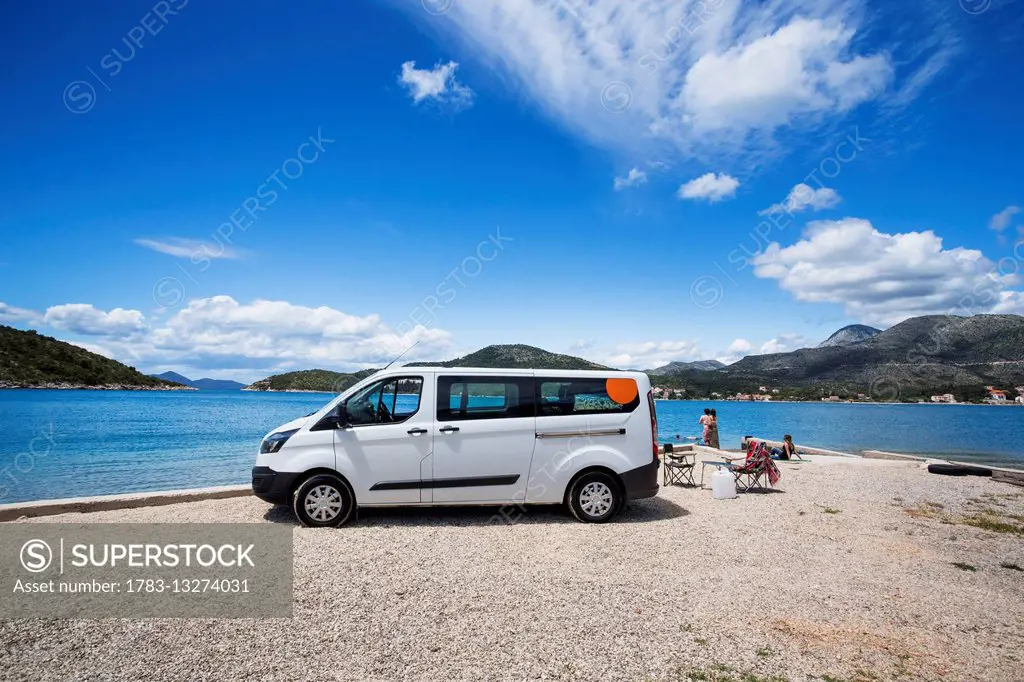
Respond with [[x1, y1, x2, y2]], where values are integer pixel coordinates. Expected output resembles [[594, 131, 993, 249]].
[[0, 0, 1024, 380]]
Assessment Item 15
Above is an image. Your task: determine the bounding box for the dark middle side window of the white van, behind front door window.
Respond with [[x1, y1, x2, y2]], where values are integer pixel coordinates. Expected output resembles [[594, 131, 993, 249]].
[[437, 376, 534, 422]]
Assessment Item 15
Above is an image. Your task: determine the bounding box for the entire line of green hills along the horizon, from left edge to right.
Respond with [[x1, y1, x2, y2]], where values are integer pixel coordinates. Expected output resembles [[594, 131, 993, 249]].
[[8, 315, 1024, 399]]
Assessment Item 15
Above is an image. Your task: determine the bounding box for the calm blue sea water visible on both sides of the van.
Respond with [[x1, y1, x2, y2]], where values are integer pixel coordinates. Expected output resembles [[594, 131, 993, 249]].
[[0, 390, 1024, 504]]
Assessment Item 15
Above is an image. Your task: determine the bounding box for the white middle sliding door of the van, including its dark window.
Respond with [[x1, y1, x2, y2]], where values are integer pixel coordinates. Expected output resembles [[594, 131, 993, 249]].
[[431, 373, 537, 503]]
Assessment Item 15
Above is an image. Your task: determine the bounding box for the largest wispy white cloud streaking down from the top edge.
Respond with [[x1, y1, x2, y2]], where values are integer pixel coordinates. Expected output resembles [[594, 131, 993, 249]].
[[391, 0, 952, 158]]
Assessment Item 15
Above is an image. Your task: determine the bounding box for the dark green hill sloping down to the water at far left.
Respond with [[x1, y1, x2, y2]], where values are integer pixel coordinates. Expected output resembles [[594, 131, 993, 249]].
[[0, 325, 185, 389]]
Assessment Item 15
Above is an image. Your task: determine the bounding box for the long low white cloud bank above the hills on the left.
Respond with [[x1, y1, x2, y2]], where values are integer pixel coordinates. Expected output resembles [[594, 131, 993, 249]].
[[6, 296, 452, 381]]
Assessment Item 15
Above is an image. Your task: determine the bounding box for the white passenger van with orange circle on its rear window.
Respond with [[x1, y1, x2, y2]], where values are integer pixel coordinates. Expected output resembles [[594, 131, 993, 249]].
[[252, 367, 659, 526]]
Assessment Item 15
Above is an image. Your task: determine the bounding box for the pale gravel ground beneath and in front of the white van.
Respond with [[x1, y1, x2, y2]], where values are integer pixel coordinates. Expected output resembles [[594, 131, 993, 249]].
[[0, 457, 1024, 682]]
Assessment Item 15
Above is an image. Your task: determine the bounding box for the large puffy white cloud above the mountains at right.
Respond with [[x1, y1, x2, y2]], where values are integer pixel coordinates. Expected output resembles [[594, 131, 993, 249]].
[[753, 218, 1019, 325]]
